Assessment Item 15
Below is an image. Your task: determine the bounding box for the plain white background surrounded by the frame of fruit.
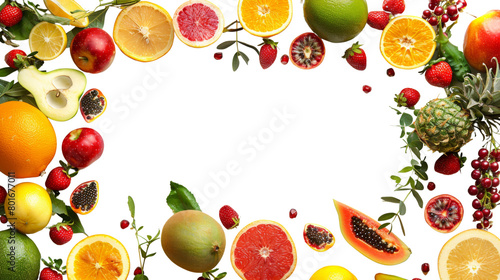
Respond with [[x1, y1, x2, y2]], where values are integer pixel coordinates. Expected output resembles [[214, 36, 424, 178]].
[[0, 0, 499, 280]]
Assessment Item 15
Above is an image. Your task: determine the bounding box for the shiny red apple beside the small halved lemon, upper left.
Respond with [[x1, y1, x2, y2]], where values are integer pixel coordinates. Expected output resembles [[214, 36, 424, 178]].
[[69, 28, 116, 73]]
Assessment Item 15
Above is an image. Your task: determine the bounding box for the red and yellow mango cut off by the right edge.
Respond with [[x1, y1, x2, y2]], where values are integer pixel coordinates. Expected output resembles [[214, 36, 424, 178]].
[[464, 10, 500, 72]]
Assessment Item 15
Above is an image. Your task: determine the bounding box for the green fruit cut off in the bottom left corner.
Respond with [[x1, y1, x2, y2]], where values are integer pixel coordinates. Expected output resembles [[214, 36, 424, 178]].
[[0, 229, 41, 280]]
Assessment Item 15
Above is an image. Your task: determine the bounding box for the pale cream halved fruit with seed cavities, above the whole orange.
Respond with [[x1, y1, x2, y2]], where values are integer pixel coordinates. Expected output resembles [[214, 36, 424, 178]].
[[17, 66, 87, 121]]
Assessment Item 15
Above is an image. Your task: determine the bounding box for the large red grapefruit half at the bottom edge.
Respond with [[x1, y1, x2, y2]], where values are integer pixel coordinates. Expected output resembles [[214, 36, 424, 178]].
[[231, 220, 297, 280]]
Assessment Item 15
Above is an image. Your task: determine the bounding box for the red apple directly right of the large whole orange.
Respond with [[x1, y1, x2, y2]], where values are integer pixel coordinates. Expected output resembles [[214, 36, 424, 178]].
[[62, 127, 104, 169]]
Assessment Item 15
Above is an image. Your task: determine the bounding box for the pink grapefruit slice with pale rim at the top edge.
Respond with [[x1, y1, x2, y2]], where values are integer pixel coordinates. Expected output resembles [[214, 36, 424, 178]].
[[173, 0, 224, 48]]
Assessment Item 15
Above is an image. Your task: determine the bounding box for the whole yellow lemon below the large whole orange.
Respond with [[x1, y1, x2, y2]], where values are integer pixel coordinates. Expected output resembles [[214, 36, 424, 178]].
[[4, 182, 52, 234]]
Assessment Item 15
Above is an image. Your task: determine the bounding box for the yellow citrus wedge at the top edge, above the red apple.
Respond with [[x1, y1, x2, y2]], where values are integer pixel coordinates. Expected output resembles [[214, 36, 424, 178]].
[[43, 0, 89, 28]]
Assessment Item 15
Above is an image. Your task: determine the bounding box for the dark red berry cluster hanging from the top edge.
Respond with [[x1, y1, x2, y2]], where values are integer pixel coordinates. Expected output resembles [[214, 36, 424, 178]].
[[422, 0, 467, 26]]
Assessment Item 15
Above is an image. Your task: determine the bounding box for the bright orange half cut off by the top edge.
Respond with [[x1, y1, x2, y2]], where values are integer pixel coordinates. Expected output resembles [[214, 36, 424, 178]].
[[238, 0, 292, 38]]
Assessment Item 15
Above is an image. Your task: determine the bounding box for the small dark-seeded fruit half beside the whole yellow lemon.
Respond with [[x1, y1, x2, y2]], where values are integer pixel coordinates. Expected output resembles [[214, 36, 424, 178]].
[[69, 181, 99, 215]]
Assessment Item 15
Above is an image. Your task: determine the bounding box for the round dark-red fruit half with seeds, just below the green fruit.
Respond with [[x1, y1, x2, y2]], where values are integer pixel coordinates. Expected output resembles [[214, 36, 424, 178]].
[[290, 32, 325, 69]]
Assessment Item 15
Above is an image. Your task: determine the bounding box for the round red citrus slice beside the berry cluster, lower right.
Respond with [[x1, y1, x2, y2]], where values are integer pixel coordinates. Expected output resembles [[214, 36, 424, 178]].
[[424, 194, 464, 233]]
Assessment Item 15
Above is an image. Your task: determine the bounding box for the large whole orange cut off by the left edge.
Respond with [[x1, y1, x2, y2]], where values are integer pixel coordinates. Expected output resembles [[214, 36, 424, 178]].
[[0, 101, 57, 178]]
